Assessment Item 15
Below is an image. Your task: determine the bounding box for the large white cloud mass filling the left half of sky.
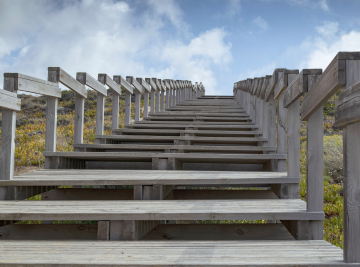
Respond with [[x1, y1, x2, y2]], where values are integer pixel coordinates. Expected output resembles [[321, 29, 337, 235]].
[[0, 0, 232, 94]]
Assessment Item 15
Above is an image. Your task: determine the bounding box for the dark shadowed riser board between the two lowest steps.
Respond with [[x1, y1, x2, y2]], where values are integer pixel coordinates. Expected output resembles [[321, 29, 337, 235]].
[[0, 223, 294, 241]]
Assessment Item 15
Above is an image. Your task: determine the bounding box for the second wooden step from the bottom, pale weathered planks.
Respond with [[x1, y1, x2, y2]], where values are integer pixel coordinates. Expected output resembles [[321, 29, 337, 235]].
[[0, 199, 324, 221]]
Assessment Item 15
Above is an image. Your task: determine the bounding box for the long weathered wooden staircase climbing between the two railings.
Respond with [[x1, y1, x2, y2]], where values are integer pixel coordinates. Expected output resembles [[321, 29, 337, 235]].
[[0, 54, 358, 266]]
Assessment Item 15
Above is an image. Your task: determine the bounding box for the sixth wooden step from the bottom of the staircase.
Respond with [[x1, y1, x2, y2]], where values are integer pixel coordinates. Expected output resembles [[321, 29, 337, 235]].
[[95, 135, 267, 145]]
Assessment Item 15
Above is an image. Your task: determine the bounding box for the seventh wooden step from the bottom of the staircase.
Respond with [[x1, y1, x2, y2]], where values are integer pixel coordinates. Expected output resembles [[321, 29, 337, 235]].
[[112, 129, 262, 137]]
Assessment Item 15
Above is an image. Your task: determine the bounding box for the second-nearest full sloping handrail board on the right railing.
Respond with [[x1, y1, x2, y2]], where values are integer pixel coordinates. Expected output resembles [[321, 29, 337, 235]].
[[284, 69, 322, 108]]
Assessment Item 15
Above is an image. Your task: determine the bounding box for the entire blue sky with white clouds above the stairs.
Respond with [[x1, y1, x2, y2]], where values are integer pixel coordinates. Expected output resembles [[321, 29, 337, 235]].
[[0, 0, 360, 95]]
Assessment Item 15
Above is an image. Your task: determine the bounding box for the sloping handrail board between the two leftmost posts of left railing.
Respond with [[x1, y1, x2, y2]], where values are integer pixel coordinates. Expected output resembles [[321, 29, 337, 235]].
[[4, 73, 61, 98]]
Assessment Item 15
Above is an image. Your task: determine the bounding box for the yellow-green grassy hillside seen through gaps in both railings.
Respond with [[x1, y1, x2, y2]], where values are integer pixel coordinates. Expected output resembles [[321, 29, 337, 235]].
[[0, 91, 343, 247]]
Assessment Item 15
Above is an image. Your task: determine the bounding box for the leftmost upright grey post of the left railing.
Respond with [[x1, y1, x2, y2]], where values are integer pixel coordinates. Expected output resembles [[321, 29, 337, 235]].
[[0, 77, 17, 180]]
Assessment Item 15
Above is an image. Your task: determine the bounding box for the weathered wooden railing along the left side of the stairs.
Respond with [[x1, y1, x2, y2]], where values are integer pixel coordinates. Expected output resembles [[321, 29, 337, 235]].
[[0, 67, 205, 180]]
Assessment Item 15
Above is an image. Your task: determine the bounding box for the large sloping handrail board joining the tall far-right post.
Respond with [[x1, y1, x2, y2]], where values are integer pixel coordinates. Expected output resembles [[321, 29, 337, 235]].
[[301, 56, 346, 121]]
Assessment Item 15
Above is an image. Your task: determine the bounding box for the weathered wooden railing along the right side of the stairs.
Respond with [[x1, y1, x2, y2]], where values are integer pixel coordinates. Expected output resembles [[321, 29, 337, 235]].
[[234, 52, 360, 263]]
